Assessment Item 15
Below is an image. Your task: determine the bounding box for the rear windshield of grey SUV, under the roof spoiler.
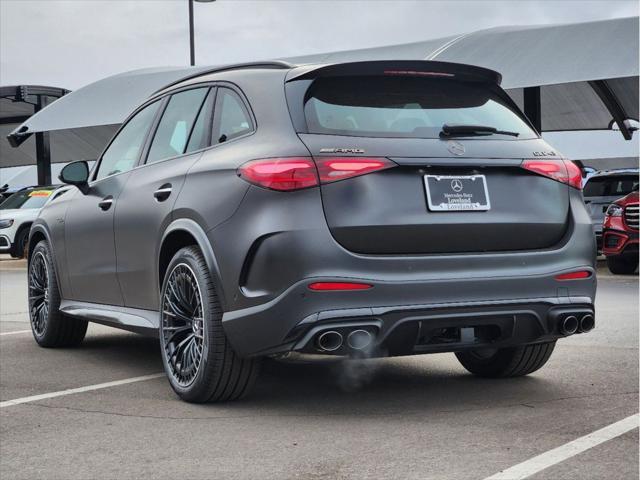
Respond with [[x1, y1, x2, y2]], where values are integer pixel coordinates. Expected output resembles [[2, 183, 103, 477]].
[[304, 76, 537, 139]]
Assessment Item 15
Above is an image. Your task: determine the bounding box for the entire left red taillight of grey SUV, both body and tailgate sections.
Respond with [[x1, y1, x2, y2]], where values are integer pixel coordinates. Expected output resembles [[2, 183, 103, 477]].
[[238, 157, 396, 192]]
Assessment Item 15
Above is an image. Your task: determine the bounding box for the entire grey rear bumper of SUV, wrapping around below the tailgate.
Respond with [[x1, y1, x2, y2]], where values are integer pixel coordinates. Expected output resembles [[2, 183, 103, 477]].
[[208, 187, 596, 356]]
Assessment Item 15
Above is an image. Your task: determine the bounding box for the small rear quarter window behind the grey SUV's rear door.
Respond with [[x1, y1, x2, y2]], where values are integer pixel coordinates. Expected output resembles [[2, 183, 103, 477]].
[[211, 88, 253, 144]]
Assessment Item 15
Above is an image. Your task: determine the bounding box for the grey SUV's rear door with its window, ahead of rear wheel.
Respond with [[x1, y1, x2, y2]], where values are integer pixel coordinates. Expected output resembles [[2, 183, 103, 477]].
[[115, 86, 215, 310]]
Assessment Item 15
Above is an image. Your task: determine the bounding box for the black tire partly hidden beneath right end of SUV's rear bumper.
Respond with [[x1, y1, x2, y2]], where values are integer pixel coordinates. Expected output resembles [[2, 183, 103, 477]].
[[456, 341, 556, 378]]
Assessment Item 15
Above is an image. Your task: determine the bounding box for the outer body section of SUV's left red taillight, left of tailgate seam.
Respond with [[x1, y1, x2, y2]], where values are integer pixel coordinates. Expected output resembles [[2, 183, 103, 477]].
[[238, 157, 318, 192]]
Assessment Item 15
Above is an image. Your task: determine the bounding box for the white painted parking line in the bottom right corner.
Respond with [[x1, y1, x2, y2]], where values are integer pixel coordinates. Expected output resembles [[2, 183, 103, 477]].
[[485, 413, 640, 480]]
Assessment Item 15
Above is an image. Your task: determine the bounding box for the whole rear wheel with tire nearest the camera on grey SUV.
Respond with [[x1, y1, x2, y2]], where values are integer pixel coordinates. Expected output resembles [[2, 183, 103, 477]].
[[159, 246, 261, 403]]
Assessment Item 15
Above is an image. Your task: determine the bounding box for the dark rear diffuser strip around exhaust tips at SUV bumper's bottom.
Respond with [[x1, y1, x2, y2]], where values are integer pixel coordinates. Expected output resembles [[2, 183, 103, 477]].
[[290, 298, 594, 356]]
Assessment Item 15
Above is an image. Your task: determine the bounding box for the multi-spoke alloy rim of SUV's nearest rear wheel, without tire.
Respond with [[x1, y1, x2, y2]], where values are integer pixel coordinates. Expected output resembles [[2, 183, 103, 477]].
[[160, 263, 205, 387]]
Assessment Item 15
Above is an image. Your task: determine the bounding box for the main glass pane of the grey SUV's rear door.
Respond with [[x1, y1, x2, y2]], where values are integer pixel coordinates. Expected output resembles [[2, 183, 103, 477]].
[[147, 88, 209, 163]]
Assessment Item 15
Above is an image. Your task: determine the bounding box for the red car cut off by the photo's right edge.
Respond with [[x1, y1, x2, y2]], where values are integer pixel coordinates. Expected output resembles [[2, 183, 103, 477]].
[[602, 190, 639, 273]]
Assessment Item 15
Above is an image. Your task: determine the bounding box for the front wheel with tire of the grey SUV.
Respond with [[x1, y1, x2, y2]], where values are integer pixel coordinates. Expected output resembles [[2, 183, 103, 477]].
[[28, 240, 87, 348]]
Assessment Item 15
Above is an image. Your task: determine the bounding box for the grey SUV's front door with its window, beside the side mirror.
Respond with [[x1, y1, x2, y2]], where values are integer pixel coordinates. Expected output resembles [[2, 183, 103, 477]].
[[64, 102, 160, 305]]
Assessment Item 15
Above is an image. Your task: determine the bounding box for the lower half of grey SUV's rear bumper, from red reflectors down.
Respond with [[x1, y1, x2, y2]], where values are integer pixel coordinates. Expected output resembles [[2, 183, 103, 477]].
[[223, 267, 596, 356]]
